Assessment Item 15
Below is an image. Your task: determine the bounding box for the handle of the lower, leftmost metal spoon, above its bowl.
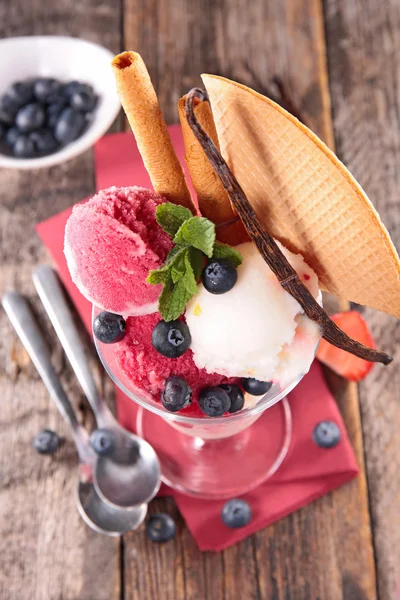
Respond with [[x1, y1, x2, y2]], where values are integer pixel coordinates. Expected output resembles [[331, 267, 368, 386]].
[[2, 292, 89, 462]]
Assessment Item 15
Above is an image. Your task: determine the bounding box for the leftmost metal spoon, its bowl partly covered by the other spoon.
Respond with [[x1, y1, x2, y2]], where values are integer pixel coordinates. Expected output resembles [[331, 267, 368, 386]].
[[2, 292, 147, 536]]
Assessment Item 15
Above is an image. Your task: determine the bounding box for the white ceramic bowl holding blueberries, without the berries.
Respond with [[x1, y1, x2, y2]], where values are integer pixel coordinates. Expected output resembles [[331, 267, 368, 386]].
[[0, 36, 121, 169]]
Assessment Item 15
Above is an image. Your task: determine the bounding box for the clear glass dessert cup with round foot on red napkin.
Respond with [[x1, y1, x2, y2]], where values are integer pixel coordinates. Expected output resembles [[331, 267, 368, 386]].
[[93, 307, 312, 500]]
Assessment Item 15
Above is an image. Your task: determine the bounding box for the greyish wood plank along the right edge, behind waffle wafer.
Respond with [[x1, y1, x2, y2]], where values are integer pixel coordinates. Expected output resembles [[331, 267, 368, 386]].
[[326, 0, 400, 599]]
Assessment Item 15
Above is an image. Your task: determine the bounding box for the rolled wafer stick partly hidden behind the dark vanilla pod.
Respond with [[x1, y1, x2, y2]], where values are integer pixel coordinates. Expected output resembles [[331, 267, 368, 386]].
[[178, 96, 250, 245]]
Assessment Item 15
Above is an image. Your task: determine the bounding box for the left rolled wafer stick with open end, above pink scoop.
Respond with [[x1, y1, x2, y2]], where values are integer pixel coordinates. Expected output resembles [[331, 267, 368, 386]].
[[112, 52, 197, 214]]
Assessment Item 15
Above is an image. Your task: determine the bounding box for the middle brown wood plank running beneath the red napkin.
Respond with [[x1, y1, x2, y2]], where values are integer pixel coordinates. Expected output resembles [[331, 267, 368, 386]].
[[124, 0, 376, 600]]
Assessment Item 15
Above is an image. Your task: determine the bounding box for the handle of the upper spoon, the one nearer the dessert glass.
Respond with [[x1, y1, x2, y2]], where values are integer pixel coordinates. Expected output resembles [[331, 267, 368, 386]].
[[33, 265, 114, 427]]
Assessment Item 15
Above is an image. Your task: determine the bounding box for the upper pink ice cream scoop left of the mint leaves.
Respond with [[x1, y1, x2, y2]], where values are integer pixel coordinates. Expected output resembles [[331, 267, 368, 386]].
[[64, 187, 172, 316]]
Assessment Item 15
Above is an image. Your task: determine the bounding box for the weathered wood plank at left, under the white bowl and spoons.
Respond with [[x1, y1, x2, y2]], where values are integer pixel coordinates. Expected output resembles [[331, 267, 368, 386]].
[[0, 0, 120, 600]]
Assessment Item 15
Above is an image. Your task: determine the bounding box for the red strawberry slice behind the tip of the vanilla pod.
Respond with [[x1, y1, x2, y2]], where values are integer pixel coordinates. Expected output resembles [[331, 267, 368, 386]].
[[317, 310, 375, 381]]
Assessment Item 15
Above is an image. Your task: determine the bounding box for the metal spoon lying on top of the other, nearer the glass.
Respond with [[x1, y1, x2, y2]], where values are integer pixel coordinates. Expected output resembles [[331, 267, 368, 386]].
[[33, 265, 161, 508]]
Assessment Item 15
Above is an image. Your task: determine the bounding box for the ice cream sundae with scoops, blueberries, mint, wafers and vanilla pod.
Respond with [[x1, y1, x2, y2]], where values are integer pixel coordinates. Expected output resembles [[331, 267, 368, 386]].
[[65, 52, 400, 418]]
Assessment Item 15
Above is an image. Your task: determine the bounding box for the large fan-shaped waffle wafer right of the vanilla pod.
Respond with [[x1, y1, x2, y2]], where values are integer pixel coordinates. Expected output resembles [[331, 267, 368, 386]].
[[203, 75, 400, 317]]
